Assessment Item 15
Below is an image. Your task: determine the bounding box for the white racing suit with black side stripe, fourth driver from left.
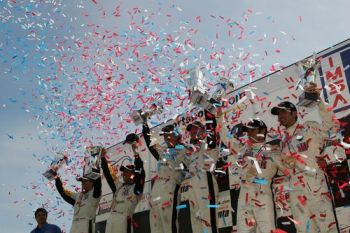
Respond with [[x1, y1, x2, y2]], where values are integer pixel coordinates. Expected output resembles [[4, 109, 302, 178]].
[[180, 142, 219, 233]]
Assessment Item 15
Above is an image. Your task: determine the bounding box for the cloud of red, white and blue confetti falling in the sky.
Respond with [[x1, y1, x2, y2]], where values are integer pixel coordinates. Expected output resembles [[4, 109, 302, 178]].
[[0, 1, 300, 230]]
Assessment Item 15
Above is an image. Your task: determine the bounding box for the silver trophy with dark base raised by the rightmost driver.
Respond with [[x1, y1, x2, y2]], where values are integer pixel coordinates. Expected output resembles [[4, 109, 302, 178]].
[[296, 54, 320, 108]]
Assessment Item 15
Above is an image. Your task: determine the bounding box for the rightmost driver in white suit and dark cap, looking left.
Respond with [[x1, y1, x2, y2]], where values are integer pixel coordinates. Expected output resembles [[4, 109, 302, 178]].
[[271, 101, 337, 233]]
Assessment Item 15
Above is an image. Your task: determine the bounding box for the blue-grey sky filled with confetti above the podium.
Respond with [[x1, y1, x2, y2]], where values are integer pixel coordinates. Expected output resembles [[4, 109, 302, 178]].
[[0, 0, 350, 233]]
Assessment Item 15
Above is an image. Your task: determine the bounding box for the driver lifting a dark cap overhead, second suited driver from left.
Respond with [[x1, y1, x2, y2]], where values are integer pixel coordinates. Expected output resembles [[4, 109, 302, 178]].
[[101, 134, 145, 233]]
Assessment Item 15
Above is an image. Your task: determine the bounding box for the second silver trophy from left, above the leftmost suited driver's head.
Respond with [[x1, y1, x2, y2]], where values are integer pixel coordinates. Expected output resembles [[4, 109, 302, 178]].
[[83, 146, 102, 180]]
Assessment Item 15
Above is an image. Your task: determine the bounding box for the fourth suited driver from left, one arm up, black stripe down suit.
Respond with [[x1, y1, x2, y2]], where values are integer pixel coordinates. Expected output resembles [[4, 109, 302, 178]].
[[180, 111, 219, 233]]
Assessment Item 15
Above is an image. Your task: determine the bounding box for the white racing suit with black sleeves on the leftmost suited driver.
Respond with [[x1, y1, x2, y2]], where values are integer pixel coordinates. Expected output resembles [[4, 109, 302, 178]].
[[56, 178, 101, 233]]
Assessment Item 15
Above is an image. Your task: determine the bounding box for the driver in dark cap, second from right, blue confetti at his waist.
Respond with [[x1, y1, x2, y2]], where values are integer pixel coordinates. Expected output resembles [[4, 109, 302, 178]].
[[219, 110, 282, 233]]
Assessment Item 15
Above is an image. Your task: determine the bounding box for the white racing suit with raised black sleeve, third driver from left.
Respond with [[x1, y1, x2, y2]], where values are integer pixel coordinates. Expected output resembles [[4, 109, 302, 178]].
[[142, 124, 188, 233]]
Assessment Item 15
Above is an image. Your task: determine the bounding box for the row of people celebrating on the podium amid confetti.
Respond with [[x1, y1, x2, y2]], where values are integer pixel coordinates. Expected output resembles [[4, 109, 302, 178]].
[[33, 90, 345, 233]]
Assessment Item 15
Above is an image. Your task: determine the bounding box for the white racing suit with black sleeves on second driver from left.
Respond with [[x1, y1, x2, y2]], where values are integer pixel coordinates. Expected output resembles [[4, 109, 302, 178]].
[[101, 157, 144, 233]]
